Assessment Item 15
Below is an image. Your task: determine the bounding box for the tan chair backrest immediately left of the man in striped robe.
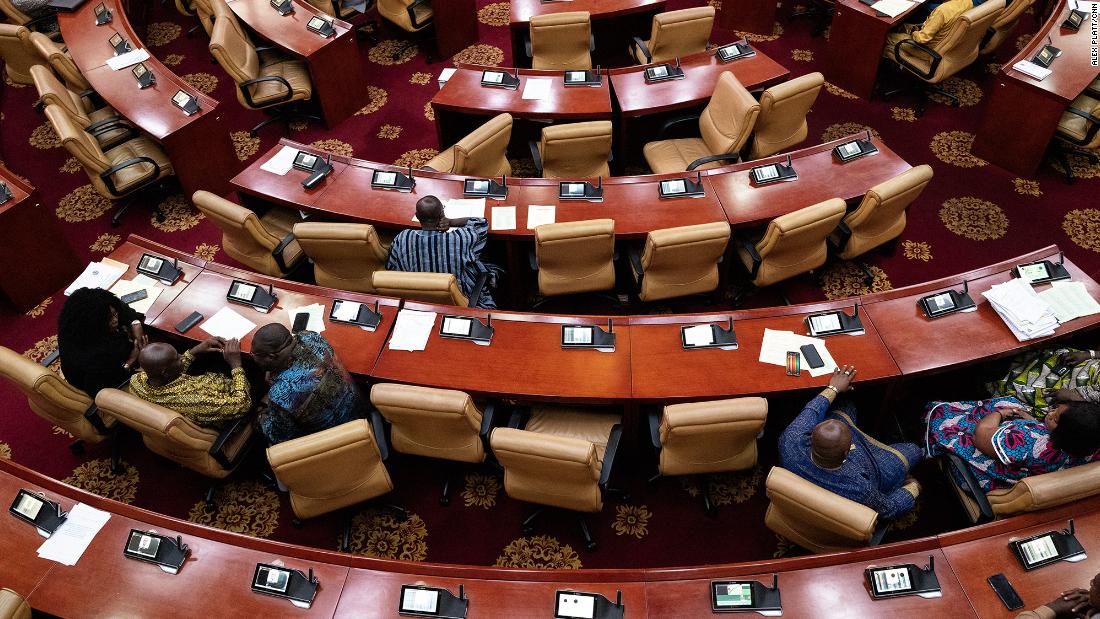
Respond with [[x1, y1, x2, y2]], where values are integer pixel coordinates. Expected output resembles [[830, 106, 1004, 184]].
[[294, 222, 389, 292]]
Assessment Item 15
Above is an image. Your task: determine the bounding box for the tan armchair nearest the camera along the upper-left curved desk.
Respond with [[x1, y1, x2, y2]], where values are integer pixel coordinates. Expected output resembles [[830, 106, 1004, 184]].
[[46, 106, 175, 225]]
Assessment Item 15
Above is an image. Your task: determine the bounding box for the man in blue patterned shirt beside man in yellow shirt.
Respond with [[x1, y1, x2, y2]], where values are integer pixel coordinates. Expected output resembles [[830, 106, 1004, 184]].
[[252, 322, 365, 445]]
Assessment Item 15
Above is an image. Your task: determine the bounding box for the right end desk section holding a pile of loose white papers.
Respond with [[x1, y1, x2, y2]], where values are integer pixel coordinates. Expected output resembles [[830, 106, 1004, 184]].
[[860, 245, 1100, 375]]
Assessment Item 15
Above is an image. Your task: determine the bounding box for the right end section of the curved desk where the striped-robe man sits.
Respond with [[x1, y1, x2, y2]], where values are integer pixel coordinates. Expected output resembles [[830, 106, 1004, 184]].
[[705, 134, 912, 228]]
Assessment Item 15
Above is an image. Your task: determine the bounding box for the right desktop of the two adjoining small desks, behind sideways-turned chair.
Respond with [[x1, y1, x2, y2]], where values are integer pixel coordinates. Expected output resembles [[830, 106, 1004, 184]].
[[611, 46, 791, 117]]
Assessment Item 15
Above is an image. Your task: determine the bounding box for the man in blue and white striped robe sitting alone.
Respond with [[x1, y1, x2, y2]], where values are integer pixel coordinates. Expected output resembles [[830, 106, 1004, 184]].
[[386, 196, 496, 309]]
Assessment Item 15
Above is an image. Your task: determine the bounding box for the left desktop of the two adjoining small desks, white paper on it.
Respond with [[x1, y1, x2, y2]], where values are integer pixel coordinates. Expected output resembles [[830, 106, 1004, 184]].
[[431, 65, 612, 120]]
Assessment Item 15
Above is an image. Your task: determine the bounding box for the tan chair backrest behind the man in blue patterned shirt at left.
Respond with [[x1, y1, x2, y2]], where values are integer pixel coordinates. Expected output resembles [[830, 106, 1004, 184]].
[[267, 419, 394, 518]]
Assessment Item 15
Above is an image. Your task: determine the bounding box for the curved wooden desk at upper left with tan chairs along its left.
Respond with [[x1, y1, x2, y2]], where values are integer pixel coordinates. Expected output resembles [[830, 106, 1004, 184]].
[[57, 0, 242, 199]]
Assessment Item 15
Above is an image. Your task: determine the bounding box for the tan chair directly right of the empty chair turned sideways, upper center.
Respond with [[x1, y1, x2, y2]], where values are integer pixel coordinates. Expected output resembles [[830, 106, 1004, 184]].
[[749, 73, 825, 159]]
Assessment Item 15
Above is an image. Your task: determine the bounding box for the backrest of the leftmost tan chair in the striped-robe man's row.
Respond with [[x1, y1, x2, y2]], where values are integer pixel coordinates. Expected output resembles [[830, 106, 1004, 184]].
[[191, 190, 282, 275]]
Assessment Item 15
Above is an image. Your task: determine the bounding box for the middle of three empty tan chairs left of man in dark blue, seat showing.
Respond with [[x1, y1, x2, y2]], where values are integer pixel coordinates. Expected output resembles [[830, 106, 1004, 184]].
[[490, 409, 623, 550]]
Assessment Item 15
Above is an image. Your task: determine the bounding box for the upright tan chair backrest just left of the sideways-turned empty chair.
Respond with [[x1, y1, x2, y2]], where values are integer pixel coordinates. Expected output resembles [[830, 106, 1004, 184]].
[[539, 120, 612, 178]]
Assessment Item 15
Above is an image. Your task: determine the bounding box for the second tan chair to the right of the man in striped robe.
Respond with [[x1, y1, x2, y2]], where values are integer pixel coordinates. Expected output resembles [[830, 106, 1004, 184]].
[[629, 221, 729, 302]]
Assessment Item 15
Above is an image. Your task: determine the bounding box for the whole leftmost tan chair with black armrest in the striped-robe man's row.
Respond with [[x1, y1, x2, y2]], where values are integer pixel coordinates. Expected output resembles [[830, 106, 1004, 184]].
[[191, 190, 305, 277]]
